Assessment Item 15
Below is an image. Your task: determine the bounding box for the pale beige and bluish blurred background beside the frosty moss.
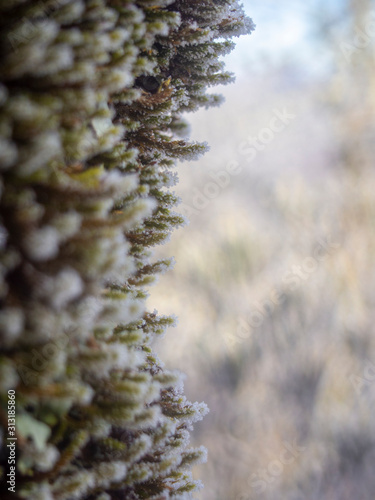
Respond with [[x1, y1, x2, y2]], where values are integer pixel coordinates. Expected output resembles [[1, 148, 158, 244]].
[[149, 0, 375, 500]]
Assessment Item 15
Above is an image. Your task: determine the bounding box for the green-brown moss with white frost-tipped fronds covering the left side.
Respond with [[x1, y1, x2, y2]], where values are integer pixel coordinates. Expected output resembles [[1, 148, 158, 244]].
[[0, 0, 252, 500]]
